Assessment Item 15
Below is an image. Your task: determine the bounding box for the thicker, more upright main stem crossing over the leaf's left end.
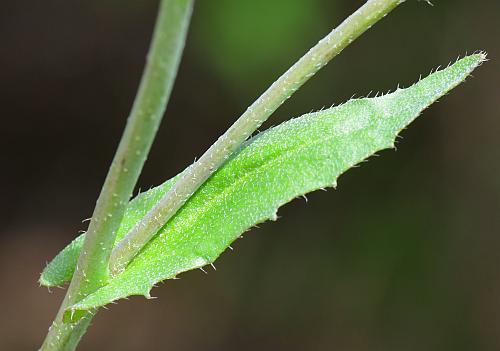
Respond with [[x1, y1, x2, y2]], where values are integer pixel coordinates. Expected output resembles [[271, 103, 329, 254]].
[[41, 0, 194, 351]]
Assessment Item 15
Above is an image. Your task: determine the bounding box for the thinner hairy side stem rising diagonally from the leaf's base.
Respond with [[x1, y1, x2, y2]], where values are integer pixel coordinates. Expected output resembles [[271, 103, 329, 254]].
[[110, 0, 405, 275]]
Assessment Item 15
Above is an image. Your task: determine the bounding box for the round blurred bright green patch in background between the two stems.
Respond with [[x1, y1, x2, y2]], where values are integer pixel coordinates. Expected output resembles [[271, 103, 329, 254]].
[[192, 0, 335, 93]]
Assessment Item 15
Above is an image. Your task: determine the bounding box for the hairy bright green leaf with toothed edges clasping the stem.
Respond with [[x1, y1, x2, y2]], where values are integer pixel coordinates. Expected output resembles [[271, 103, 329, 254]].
[[41, 54, 485, 316]]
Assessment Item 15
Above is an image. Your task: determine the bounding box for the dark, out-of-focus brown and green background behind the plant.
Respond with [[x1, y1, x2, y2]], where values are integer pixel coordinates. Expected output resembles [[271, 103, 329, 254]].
[[0, 0, 500, 351]]
